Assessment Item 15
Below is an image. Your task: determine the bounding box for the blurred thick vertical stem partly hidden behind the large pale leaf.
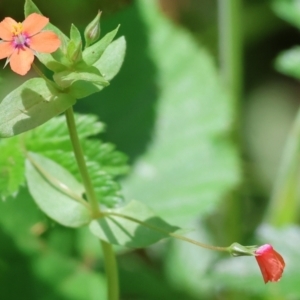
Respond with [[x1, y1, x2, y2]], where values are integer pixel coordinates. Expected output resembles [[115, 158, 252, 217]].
[[218, 0, 242, 243]]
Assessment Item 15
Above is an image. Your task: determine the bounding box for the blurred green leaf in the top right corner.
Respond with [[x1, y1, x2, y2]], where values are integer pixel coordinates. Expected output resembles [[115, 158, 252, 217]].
[[272, 0, 300, 29]]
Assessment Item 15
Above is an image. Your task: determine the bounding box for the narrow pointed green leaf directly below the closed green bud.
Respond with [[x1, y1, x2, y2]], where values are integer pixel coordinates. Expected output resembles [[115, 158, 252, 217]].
[[82, 26, 120, 65]]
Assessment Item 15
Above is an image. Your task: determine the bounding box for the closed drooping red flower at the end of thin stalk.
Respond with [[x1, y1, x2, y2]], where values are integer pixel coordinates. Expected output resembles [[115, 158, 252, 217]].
[[255, 244, 285, 283]]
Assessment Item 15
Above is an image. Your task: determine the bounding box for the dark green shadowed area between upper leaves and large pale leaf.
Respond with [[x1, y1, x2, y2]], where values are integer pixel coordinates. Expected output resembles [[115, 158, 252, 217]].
[[75, 1, 157, 161]]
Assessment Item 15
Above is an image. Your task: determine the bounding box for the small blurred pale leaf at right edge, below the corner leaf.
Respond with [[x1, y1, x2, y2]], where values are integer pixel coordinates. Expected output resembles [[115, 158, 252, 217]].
[[275, 46, 300, 79]]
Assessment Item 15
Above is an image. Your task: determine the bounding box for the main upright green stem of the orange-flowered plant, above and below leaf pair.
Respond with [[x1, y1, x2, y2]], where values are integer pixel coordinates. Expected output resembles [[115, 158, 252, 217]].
[[65, 107, 119, 300]]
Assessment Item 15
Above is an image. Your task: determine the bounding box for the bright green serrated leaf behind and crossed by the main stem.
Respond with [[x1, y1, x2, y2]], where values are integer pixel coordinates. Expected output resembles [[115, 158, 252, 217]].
[[26, 115, 128, 207]]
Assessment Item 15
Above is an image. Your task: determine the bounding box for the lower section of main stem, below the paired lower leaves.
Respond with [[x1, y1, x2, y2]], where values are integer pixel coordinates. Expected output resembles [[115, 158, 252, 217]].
[[101, 241, 119, 300]]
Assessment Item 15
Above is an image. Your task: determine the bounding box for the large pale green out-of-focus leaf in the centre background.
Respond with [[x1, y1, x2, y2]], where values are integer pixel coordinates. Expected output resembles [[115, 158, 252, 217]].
[[123, 1, 240, 226]]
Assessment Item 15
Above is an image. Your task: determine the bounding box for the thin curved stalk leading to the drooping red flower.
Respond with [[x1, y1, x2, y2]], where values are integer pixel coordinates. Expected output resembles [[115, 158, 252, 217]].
[[102, 211, 228, 252]]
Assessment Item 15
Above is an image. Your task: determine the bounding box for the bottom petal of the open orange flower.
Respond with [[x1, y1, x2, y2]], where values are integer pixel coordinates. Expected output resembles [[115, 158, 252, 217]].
[[10, 47, 34, 75]]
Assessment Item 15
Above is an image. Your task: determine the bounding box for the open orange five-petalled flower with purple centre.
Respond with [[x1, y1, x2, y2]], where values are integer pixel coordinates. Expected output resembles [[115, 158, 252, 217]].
[[0, 13, 60, 75]]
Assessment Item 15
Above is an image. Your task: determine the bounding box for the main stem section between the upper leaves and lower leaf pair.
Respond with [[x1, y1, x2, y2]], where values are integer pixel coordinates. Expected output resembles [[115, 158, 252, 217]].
[[65, 107, 100, 216]]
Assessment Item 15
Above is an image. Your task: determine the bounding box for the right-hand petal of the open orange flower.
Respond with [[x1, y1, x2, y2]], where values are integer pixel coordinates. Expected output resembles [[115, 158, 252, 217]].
[[29, 31, 61, 53]]
